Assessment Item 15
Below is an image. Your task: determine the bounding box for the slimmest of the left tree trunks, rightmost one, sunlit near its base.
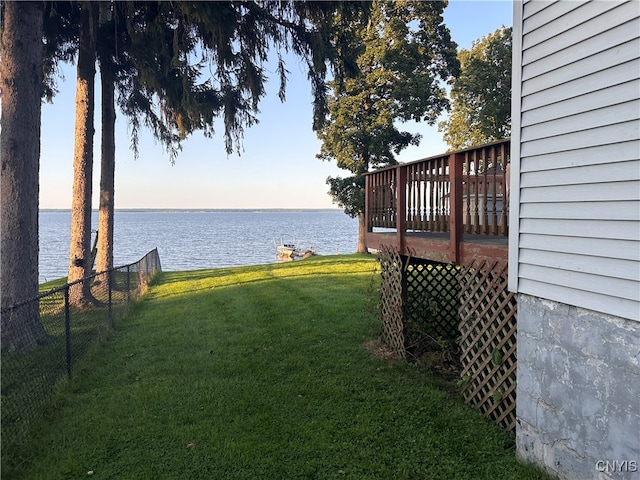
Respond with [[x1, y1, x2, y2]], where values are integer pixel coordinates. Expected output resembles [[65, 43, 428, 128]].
[[96, 19, 116, 272]]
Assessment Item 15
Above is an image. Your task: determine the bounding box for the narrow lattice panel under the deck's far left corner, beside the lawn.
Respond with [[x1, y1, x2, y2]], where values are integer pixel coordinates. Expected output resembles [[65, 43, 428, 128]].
[[379, 246, 405, 358]]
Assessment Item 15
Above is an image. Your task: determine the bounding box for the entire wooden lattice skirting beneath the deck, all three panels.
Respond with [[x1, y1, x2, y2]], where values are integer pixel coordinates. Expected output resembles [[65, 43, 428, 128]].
[[380, 247, 517, 431]]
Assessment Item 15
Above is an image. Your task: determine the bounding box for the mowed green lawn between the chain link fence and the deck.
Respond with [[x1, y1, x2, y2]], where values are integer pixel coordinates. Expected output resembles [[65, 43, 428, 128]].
[[2, 255, 547, 480]]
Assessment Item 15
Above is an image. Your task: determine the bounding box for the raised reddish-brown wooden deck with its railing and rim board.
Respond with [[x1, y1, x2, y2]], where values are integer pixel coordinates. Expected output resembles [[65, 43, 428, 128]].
[[365, 139, 510, 265]]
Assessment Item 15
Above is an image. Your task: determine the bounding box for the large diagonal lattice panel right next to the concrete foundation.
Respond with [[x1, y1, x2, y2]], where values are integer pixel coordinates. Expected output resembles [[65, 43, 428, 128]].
[[460, 259, 517, 430]]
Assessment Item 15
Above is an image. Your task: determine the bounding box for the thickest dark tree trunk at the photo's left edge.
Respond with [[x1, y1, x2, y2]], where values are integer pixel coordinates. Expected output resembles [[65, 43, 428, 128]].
[[0, 2, 46, 351]]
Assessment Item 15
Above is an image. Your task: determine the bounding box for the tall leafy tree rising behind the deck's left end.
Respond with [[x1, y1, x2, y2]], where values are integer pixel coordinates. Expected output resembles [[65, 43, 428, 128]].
[[317, 0, 458, 252]]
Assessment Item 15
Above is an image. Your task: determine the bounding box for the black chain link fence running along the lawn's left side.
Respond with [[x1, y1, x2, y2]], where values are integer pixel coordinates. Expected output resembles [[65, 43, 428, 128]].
[[0, 249, 162, 454]]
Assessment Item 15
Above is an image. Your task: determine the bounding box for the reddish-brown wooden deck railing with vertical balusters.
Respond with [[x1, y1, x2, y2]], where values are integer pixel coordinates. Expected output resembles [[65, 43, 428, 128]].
[[365, 139, 510, 262]]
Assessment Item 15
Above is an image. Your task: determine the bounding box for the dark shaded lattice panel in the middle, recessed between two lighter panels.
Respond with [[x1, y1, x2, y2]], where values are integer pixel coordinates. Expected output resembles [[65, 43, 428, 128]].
[[404, 258, 460, 343]]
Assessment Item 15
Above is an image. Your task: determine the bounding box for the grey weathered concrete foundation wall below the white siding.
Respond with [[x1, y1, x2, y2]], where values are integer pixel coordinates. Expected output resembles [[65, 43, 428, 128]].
[[516, 294, 640, 480]]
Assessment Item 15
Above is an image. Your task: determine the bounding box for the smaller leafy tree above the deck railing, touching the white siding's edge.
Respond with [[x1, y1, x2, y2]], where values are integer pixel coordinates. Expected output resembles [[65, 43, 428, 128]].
[[438, 27, 511, 150]]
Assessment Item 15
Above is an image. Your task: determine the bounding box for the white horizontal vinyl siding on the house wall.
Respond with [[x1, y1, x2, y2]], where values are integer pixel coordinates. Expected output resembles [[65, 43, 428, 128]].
[[509, 1, 640, 321]]
